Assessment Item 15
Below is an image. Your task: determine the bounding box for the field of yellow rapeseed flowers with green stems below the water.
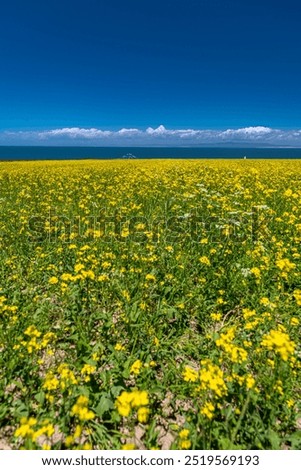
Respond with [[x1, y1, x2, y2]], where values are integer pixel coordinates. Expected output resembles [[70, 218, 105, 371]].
[[0, 160, 301, 449]]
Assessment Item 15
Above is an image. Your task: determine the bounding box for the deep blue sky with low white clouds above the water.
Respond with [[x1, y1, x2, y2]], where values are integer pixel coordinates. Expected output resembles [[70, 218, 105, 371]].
[[0, 0, 301, 145]]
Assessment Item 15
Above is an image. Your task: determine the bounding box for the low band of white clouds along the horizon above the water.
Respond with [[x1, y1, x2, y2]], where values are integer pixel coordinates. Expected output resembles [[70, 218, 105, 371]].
[[0, 125, 301, 147]]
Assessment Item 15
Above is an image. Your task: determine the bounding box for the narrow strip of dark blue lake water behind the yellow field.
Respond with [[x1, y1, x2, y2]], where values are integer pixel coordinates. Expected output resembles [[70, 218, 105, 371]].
[[0, 146, 301, 160]]
